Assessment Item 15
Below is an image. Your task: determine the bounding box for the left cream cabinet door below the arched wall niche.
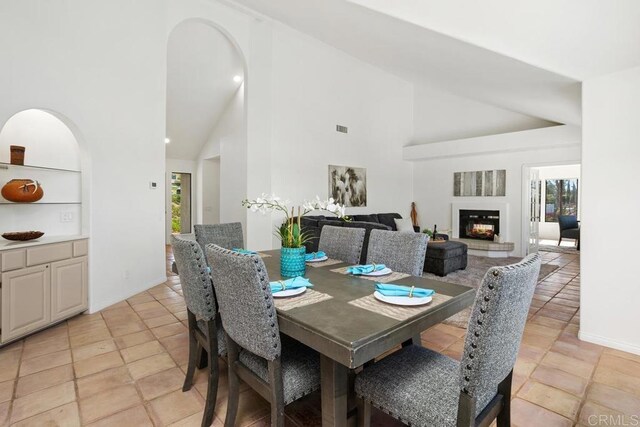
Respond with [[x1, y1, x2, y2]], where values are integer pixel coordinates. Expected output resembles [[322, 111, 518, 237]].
[[2, 264, 51, 342]]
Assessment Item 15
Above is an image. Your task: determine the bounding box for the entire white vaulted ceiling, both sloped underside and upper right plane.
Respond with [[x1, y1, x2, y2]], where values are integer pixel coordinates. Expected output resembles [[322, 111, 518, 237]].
[[235, 0, 640, 128]]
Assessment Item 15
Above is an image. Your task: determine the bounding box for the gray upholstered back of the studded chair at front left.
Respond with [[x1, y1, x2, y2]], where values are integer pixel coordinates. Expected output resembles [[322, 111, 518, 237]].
[[205, 244, 281, 360]]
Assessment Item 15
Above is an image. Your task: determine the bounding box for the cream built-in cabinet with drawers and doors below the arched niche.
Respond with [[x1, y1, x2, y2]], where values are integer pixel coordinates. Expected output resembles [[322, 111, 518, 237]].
[[0, 239, 88, 344]]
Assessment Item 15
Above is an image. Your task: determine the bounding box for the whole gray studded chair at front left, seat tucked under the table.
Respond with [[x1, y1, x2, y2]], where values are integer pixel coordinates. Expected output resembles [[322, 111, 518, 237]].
[[206, 245, 320, 427]]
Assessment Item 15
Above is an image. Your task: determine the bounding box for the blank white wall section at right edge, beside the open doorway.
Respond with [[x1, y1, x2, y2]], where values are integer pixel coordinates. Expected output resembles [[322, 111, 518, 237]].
[[580, 67, 640, 354]]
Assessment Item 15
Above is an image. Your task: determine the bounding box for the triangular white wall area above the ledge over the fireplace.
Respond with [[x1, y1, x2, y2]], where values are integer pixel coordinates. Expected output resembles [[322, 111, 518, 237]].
[[411, 85, 555, 144]]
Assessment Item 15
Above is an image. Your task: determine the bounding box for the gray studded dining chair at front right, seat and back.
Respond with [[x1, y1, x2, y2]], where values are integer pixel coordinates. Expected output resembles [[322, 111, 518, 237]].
[[355, 253, 540, 427]]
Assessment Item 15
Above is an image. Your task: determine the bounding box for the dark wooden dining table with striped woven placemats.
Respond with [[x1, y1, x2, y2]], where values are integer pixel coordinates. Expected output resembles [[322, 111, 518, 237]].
[[261, 250, 476, 427]]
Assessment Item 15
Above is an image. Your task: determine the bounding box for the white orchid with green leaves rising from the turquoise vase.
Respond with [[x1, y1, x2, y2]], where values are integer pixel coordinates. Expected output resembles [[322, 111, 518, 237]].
[[242, 193, 349, 248]]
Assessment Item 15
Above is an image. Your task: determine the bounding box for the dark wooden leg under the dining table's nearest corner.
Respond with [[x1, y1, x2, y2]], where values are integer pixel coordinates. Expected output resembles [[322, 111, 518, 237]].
[[320, 354, 349, 427]]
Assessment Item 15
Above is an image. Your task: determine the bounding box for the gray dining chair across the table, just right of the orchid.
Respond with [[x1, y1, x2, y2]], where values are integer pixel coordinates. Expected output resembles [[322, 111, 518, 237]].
[[318, 225, 365, 264]]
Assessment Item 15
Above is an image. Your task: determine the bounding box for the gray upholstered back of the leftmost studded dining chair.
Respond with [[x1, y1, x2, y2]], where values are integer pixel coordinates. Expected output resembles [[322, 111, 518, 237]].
[[171, 235, 217, 320]]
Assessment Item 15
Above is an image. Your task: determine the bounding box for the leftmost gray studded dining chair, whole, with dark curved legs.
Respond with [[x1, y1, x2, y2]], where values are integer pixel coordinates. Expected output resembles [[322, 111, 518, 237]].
[[171, 235, 226, 426]]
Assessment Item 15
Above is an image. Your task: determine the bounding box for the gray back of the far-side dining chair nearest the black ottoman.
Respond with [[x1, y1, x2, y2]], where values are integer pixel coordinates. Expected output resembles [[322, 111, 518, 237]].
[[367, 230, 429, 276]]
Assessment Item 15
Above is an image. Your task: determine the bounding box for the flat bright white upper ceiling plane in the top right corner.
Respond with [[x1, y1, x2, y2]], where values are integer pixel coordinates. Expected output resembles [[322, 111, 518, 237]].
[[348, 0, 640, 80]]
